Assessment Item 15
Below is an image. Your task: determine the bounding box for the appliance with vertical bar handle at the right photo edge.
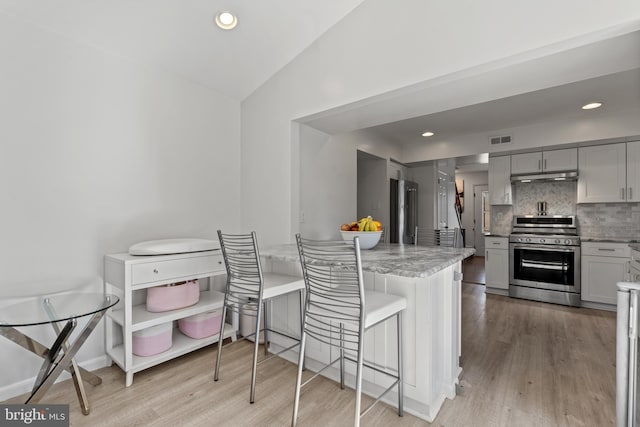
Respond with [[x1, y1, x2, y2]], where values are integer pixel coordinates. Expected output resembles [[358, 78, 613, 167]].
[[616, 282, 640, 427]]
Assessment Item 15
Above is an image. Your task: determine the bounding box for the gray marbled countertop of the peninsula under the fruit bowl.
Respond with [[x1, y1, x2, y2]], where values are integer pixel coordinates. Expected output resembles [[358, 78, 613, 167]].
[[260, 243, 476, 278]]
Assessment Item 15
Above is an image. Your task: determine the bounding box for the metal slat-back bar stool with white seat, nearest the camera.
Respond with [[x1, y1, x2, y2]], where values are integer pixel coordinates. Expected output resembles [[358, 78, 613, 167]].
[[291, 234, 407, 426]]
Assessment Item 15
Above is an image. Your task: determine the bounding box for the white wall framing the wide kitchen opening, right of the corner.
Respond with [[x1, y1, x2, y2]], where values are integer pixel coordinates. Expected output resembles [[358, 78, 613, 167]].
[[242, 0, 640, 243]]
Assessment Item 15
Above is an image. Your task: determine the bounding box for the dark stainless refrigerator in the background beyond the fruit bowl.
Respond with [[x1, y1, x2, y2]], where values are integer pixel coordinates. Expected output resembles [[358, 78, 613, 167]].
[[389, 178, 418, 244]]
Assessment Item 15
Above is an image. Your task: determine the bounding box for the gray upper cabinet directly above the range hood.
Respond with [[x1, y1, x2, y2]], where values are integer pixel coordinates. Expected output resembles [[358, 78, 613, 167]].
[[511, 148, 578, 175]]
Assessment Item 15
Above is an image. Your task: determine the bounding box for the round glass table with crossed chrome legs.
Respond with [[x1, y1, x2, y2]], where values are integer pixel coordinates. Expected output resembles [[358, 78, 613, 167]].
[[0, 293, 119, 415]]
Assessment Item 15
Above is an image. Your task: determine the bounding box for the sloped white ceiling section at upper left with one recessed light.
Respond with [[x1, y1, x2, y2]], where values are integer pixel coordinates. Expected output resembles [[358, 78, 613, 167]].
[[0, 0, 363, 100]]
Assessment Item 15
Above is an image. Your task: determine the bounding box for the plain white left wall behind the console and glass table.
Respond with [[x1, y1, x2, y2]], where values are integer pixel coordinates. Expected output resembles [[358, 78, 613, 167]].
[[0, 13, 241, 400]]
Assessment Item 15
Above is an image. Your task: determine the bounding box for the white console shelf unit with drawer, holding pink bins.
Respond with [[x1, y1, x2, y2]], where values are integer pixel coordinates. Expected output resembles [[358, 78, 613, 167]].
[[104, 250, 238, 387]]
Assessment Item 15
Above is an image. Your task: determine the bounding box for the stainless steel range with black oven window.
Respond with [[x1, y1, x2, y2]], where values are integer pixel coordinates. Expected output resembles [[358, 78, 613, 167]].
[[509, 215, 580, 306]]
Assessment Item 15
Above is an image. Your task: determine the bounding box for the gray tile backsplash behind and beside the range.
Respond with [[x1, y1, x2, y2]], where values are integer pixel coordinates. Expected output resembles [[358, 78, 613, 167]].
[[491, 181, 640, 239]]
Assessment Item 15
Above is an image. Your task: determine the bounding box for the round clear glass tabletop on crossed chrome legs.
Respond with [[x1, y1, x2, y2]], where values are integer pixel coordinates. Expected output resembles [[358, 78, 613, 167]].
[[0, 293, 119, 328]]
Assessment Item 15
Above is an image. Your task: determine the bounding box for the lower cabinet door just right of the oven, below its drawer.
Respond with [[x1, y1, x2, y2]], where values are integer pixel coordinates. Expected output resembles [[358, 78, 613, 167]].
[[581, 256, 629, 305]]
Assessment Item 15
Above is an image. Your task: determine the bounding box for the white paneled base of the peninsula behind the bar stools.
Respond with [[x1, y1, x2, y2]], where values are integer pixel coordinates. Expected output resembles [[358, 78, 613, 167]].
[[263, 249, 464, 422]]
